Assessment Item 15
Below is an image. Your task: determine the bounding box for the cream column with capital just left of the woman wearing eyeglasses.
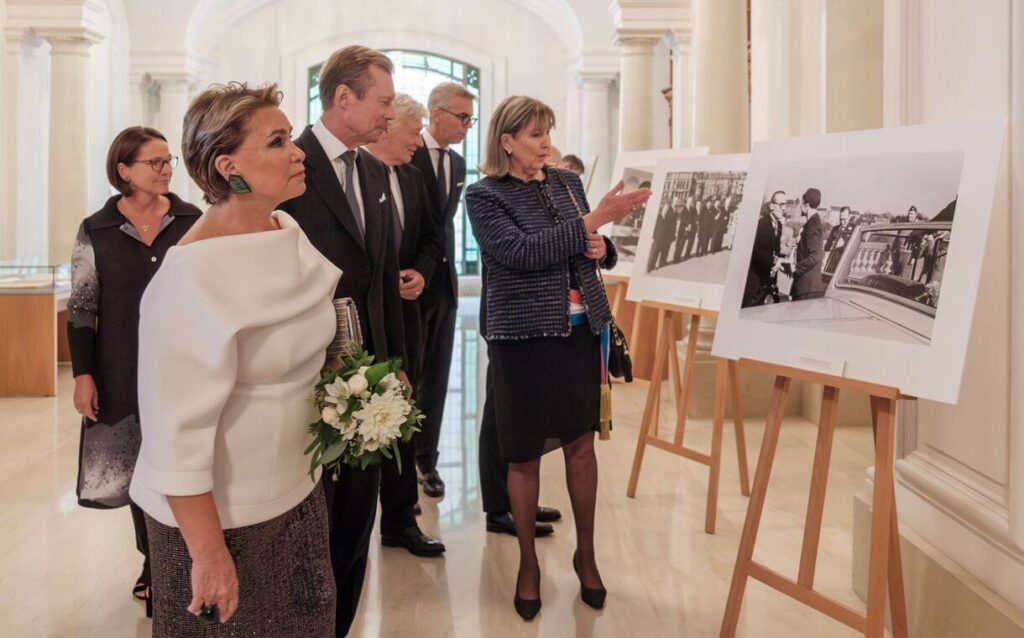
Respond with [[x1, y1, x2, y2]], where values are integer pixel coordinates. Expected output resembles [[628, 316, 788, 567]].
[[40, 30, 99, 263]]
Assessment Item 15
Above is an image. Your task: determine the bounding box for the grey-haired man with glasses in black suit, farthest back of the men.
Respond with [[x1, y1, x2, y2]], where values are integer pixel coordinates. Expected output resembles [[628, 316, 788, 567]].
[[413, 82, 476, 498]]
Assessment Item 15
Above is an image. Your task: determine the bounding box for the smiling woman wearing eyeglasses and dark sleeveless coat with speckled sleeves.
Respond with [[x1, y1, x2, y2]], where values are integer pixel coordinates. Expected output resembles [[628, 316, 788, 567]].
[[68, 126, 201, 612]]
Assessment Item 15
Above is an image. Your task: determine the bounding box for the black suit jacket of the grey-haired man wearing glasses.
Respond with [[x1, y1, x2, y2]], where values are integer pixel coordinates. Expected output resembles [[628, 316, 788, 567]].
[[412, 138, 466, 297]]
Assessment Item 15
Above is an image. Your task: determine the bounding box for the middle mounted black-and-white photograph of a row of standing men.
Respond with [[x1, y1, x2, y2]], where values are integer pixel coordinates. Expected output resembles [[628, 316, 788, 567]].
[[627, 155, 750, 309]]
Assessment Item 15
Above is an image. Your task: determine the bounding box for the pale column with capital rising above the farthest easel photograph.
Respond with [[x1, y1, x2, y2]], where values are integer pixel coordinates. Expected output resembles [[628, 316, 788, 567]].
[[615, 35, 662, 151]]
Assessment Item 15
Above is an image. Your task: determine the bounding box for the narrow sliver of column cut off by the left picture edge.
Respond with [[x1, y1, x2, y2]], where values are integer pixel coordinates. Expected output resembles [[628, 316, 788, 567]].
[[0, 29, 25, 259]]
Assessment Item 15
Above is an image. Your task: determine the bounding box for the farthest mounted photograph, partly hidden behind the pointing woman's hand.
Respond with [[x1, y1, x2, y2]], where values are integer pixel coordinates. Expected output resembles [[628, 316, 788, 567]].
[[591, 146, 708, 275]]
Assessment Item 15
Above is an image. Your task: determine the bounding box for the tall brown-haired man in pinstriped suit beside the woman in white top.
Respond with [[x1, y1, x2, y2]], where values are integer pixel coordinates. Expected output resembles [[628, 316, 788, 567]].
[[281, 46, 408, 636]]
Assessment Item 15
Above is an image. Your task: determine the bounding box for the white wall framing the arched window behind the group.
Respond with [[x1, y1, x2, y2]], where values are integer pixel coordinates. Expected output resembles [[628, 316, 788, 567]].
[[183, 0, 585, 152]]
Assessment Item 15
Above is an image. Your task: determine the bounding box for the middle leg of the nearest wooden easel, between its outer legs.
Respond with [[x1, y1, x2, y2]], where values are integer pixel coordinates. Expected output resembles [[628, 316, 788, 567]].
[[797, 385, 839, 589]]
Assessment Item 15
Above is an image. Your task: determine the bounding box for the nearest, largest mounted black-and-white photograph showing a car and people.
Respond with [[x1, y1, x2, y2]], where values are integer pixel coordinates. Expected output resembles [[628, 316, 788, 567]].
[[714, 122, 1005, 402]]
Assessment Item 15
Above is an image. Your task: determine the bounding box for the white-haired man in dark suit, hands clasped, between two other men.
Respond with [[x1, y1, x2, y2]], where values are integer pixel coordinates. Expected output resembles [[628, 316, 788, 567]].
[[367, 93, 444, 556]]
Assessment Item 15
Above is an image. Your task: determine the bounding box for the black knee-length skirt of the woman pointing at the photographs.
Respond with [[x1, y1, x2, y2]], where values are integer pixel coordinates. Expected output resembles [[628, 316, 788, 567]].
[[487, 324, 601, 463]]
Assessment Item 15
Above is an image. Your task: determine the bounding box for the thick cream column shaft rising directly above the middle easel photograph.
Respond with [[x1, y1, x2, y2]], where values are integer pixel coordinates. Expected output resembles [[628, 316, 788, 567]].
[[693, 0, 750, 154]]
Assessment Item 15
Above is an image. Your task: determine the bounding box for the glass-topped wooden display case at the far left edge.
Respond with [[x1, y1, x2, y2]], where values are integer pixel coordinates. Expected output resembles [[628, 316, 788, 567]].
[[0, 261, 71, 396]]
